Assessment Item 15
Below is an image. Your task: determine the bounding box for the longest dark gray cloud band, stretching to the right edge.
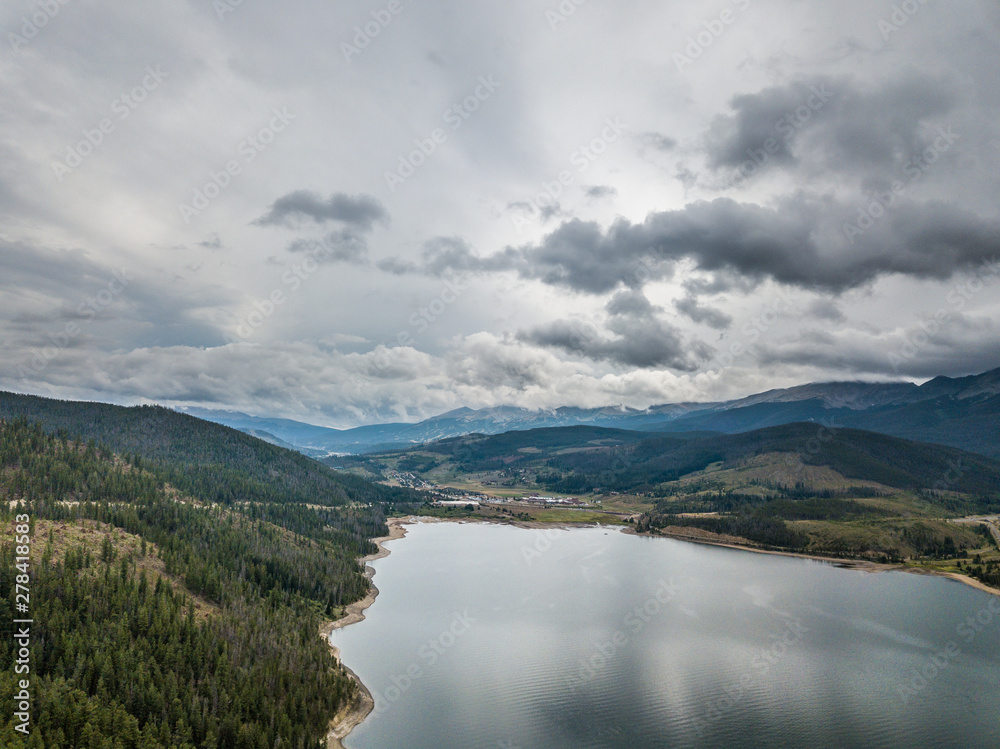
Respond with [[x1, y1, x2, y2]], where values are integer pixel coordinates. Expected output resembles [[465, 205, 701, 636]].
[[382, 195, 1000, 294]]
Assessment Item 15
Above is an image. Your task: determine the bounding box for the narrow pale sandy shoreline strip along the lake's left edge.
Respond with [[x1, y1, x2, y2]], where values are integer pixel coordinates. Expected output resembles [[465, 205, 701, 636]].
[[319, 517, 416, 749]]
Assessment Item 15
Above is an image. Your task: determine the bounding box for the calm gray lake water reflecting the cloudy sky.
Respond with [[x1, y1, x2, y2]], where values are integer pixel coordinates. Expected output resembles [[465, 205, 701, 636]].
[[332, 523, 1000, 749]]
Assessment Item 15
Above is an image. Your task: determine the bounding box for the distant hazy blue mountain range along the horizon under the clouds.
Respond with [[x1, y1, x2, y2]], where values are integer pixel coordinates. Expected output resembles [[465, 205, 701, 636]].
[[176, 369, 1000, 457]]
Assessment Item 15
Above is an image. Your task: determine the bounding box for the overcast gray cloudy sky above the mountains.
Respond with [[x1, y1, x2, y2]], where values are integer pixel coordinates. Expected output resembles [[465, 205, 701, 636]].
[[0, 0, 1000, 427]]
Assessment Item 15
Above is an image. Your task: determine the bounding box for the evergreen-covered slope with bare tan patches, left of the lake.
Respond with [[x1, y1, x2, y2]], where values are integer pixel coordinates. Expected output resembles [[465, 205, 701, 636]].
[[0, 418, 422, 749]]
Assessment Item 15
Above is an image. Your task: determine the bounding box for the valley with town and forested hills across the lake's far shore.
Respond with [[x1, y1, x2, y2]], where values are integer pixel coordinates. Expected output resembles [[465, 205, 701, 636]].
[[327, 424, 1000, 587]]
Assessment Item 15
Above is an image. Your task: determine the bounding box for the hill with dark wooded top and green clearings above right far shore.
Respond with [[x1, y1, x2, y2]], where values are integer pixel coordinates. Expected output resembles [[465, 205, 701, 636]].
[[620, 424, 1000, 572]]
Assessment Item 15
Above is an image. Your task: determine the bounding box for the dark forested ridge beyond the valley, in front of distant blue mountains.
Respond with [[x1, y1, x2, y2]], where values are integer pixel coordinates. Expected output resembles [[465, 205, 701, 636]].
[[362, 423, 1000, 495]]
